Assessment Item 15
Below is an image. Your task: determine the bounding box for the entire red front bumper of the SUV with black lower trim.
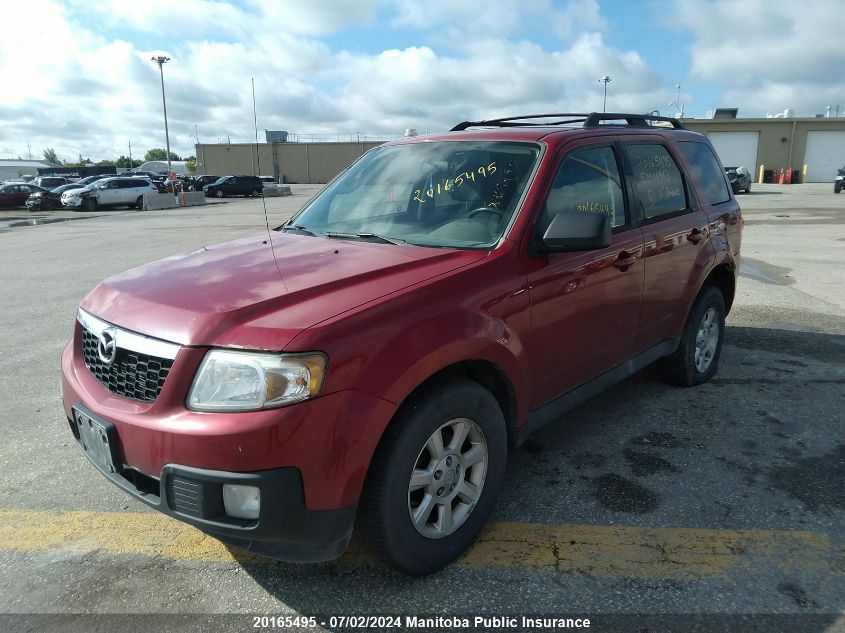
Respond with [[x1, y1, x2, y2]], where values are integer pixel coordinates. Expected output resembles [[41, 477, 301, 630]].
[[61, 322, 395, 562]]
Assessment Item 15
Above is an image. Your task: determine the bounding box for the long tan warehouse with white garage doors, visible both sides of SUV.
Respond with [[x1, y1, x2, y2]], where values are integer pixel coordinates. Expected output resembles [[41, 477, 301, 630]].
[[196, 117, 845, 183]]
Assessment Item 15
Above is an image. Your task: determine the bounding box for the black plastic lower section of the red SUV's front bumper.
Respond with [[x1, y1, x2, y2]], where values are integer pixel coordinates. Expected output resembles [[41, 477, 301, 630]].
[[68, 406, 356, 563]]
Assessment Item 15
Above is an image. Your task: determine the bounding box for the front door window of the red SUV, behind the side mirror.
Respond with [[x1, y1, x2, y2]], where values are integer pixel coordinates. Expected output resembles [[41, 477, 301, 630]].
[[537, 147, 625, 235]]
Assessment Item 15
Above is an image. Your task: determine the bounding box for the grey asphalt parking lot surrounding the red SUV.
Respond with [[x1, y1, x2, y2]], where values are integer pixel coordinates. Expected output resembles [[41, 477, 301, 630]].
[[0, 184, 845, 631]]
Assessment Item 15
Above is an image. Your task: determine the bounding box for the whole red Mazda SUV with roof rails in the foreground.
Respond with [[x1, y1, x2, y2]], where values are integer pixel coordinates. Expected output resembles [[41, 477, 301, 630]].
[[62, 113, 743, 574]]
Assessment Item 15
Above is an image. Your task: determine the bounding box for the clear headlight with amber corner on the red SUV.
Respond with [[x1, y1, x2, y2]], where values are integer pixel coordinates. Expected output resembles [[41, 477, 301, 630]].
[[188, 349, 326, 411]]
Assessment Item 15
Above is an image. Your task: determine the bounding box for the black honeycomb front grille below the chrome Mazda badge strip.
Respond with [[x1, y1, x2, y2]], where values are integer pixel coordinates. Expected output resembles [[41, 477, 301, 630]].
[[82, 326, 173, 402]]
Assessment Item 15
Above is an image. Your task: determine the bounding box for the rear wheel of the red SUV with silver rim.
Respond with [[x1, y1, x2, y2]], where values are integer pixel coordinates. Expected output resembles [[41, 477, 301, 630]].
[[659, 286, 725, 387]]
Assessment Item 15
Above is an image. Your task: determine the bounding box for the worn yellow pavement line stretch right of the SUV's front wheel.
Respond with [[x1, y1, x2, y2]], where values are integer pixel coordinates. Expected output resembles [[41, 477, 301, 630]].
[[461, 523, 845, 578]]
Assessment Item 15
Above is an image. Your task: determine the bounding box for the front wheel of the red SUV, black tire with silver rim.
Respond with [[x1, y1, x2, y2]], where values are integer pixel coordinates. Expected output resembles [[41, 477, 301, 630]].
[[358, 380, 507, 576]]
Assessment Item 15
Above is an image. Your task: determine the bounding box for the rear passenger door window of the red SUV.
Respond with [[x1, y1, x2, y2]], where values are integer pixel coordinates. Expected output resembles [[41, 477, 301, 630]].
[[627, 143, 687, 219]]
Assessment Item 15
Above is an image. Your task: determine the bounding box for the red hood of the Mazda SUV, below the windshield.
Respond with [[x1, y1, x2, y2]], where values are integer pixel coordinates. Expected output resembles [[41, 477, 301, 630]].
[[81, 232, 487, 350]]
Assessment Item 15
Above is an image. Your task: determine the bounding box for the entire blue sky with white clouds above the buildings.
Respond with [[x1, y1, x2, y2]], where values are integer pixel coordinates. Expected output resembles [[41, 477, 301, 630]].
[[0, 0, 845, 161]]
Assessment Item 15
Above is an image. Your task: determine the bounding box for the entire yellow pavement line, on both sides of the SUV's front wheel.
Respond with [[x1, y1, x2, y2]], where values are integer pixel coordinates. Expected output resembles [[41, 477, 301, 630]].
[[0, 509, 845, 579]]
